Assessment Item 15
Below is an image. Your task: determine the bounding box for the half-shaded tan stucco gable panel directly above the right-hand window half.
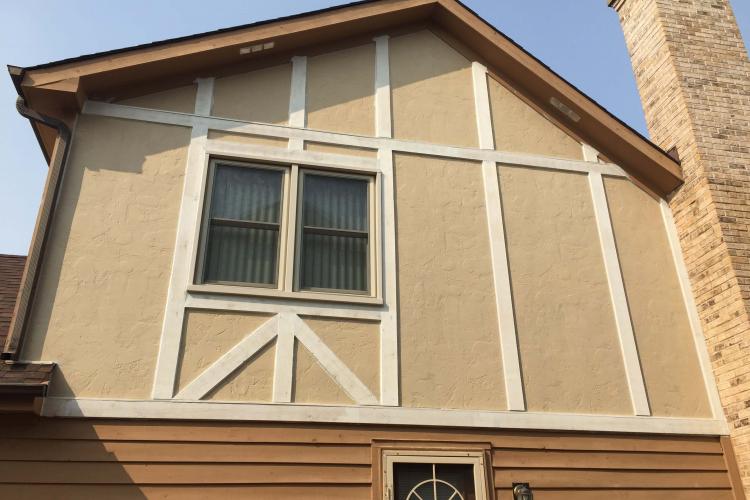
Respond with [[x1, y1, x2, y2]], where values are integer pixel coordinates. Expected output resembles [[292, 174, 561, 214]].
[[306, 43, 375, 135]]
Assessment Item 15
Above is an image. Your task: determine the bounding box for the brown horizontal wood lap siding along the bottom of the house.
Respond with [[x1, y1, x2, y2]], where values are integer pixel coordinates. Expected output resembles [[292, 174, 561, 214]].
[[0, 416, 744, 500]]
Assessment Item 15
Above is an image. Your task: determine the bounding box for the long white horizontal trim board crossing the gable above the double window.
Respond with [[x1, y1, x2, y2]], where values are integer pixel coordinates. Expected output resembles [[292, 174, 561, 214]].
[[83, 101, 627, 177]]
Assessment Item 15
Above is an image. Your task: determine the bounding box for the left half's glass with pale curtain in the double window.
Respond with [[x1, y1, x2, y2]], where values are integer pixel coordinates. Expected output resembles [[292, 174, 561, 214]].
[[203, 164, 283, 285]]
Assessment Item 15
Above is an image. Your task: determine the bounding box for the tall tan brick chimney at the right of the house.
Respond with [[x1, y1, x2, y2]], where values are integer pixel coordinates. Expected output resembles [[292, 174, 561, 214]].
[[609, 0, 750, 491]]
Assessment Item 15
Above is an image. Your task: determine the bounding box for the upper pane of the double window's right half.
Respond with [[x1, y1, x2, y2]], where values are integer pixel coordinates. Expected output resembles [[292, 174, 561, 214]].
[[302, 174, 368, 231]]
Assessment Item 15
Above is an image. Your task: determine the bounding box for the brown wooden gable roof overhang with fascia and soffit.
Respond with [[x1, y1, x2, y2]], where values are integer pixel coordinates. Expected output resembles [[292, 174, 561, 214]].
[[9, 0, 682, 195]]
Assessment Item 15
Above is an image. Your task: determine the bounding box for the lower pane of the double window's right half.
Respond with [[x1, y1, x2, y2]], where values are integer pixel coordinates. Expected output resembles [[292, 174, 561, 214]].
[[300, 233, 368, 291]]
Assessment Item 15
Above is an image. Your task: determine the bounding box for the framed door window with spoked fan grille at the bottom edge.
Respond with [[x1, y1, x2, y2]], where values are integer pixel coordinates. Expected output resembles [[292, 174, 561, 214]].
[[383, 451, 487, 500]]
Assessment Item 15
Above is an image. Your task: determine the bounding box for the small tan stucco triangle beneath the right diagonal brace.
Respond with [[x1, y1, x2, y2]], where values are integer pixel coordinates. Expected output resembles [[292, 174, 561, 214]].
[[292, 340, 354, 405]]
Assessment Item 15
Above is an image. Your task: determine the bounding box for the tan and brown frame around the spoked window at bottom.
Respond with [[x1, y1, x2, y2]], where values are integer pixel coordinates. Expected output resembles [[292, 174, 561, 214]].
[[382, 450, 491, 500]]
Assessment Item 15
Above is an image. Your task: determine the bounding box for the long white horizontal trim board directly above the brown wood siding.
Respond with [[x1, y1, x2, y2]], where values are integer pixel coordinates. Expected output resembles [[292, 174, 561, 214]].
[[42, 397, 728, 436]]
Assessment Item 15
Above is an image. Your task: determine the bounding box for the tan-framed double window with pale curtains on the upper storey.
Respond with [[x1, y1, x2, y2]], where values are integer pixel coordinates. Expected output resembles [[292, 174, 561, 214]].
[[196, 160, 376, 296]]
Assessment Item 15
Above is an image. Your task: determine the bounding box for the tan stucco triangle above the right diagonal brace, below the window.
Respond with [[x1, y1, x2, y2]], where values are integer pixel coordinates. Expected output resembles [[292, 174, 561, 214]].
[[303, 316, 380, 397]]
